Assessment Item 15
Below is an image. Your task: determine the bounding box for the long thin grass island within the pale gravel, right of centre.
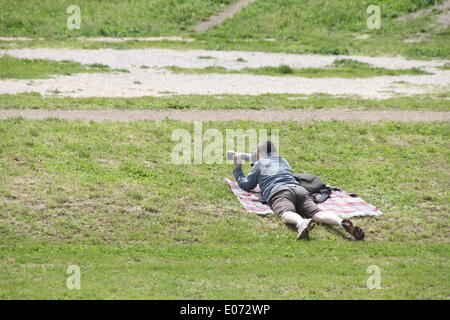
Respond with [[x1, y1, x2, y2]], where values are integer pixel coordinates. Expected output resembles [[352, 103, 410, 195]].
[[166, 59, 431, 78]]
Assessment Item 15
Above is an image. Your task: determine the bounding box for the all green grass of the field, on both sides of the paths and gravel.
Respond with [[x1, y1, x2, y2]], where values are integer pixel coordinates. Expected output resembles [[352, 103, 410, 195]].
[[0, 0, 450, 300]]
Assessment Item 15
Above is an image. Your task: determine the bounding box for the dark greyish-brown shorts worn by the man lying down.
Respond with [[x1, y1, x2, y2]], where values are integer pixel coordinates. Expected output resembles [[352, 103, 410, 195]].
[[268, 185, 320, 219]]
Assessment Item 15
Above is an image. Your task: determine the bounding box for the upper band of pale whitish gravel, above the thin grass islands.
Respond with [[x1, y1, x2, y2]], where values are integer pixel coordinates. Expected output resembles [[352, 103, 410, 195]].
[[0, 48, 450, 71]]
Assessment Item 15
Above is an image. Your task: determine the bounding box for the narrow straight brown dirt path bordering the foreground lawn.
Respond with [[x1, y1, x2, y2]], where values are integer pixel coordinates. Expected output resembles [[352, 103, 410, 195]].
[[0, 109, 450, 122]]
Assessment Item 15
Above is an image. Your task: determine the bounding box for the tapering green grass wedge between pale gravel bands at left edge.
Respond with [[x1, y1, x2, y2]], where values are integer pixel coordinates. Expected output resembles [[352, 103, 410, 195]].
[[0, 55, 127, 79]]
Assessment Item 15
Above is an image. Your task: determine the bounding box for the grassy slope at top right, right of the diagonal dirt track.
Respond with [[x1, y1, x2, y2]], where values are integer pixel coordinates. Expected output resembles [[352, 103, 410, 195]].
[[204, 0, 450, 57]]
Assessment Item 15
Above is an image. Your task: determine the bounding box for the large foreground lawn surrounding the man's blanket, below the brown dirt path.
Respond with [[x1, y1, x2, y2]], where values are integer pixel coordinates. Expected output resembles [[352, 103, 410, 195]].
[[0, 119, 450, 299]]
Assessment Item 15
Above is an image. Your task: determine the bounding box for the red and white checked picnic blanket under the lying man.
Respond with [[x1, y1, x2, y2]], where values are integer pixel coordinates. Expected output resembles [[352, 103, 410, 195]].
[[224, 178, 383, 219]]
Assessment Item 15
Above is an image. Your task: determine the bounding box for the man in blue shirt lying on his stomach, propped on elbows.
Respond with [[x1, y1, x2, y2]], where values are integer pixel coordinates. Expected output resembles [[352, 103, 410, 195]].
[[233, 141, 364, 240]]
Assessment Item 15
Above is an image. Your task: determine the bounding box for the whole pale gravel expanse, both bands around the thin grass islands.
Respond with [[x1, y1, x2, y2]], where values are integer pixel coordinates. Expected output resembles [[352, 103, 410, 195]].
[[0, 48, 450, 98]]
